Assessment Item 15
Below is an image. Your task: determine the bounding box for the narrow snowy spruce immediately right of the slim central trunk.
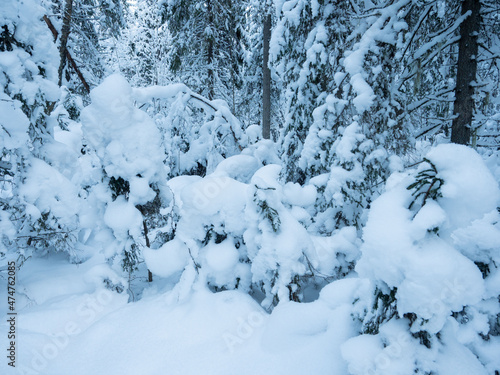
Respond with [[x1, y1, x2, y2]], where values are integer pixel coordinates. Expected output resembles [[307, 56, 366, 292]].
[[270, 1, 344, 183]]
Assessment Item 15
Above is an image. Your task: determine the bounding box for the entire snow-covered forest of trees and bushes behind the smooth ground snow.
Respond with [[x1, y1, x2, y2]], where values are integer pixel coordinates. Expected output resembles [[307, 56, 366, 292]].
[[0, 0, 500, 375]]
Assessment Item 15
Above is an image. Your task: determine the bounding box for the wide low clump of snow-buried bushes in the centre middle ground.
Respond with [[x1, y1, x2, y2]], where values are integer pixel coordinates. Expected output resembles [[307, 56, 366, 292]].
[[145, 152, 358, 309]]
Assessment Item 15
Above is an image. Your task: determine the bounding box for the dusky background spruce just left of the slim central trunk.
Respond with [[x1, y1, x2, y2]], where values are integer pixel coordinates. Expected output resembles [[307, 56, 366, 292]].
[[163, 0, 244, 104]]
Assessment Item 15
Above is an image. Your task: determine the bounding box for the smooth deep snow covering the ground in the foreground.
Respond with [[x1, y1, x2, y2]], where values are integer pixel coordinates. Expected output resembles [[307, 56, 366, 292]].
[[1, 254, 354, 375]]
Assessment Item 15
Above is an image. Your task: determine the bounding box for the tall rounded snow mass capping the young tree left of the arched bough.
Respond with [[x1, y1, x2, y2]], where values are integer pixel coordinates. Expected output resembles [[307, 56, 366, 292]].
[[81, 74, 165, 185]]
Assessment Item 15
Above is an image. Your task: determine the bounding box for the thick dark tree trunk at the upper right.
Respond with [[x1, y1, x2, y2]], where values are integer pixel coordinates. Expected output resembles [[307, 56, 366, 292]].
[[451, 0, 481, 145]]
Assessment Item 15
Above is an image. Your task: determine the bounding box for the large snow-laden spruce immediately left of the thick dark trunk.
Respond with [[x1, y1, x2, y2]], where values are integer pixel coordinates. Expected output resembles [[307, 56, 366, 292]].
[[299, 1, 482, 233]]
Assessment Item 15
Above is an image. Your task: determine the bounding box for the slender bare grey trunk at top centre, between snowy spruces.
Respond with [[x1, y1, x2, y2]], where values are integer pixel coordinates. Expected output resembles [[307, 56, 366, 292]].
[[262, 13, 271, 139]]
